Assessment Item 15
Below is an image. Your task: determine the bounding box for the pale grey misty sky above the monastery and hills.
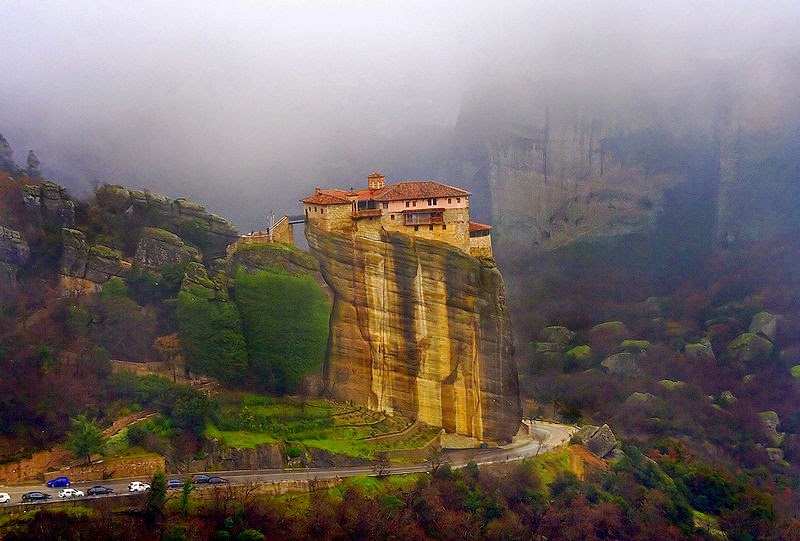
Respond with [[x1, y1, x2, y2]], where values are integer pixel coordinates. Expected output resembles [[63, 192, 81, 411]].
[[0, 0, 800, 230]]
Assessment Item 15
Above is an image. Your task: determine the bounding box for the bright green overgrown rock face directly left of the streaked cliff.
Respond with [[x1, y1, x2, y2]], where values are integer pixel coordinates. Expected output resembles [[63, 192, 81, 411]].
[[234, 270, 330, 394]]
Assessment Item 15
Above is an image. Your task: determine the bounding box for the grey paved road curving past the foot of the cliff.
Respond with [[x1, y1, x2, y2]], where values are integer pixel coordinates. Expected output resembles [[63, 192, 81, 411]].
[[0, 419, 577, 507]]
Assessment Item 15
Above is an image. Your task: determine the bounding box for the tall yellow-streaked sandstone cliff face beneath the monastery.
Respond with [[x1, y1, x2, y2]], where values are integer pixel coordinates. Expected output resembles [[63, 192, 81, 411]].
[[306, 224, 521, 440]]
